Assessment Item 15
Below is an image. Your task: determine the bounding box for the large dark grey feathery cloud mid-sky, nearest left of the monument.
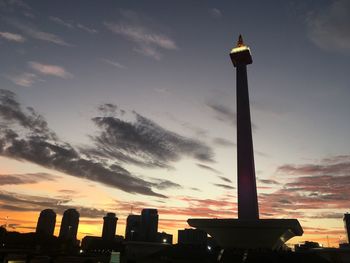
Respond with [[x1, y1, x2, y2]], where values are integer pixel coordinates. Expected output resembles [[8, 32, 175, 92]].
[[85, 104, 213, 168]]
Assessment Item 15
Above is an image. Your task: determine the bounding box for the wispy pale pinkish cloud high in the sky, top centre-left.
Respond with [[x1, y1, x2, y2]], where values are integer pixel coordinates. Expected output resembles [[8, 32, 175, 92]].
[[104, 11, 178, 60]]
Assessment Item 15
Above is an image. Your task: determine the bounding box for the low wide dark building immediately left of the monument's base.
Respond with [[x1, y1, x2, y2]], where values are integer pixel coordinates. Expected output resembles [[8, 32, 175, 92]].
[[177, 228, 208, 246]]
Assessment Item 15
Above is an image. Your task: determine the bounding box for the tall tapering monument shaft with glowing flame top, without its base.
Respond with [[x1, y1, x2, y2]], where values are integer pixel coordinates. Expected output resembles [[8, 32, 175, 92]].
[[230, 35, 259, 220]]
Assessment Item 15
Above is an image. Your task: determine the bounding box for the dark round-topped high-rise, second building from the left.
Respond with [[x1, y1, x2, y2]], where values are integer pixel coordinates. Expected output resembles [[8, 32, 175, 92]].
[[59, 208, 79, 240]]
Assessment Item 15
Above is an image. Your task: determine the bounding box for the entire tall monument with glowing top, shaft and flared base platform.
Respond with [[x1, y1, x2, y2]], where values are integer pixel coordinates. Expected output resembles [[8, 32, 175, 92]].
[[188, 36, 303, 250]]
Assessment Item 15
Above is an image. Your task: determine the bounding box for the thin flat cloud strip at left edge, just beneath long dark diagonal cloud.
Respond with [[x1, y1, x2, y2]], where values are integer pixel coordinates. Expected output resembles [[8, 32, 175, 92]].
[[0, 173, 60, 185]]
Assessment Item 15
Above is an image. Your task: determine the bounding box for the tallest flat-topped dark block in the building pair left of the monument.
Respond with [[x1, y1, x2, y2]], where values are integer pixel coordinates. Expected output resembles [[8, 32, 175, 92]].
[[140, 208, 158, 242]]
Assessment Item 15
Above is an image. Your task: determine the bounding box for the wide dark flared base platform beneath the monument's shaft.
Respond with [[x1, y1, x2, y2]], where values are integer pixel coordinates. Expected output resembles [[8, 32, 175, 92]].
[[187, 219, 303, 250]]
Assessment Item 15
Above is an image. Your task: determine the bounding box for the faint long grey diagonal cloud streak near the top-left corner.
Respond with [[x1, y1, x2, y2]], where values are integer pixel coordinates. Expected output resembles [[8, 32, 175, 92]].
[[5, 19, 72, 46]]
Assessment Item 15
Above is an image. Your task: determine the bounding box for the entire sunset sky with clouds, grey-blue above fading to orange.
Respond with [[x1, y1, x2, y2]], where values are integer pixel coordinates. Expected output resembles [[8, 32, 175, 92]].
[[0, 0, 350, 246]]
